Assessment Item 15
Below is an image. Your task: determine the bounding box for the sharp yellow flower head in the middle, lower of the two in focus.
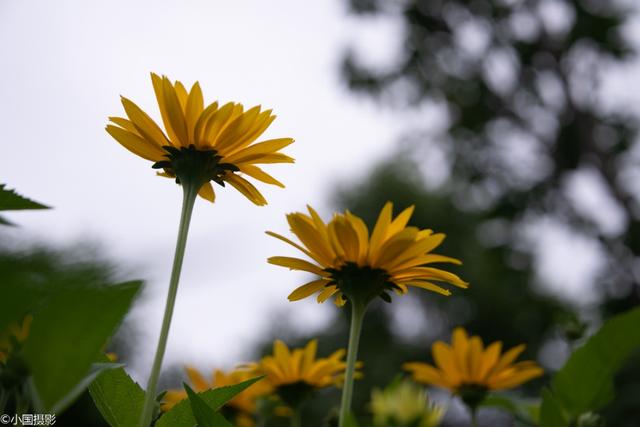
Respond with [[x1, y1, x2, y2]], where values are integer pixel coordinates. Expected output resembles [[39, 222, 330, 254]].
[[267, 202, 468, 306]]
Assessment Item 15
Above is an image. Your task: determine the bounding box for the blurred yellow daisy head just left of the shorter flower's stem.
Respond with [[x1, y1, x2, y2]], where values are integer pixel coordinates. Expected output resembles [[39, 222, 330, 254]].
[[250, 340, 346, 407]]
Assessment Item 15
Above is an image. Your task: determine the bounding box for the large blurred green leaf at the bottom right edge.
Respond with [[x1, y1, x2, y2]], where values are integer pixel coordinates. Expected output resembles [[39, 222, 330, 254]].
[[552, 308, 640, 417]]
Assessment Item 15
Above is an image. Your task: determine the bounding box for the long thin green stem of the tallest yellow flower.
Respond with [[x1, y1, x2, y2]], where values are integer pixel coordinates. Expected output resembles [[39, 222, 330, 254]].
[[139, 182, 199, 427]]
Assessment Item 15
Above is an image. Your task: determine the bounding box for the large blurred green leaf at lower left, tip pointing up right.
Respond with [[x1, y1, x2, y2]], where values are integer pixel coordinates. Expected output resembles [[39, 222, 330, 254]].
[[24, 282, 141, 412]]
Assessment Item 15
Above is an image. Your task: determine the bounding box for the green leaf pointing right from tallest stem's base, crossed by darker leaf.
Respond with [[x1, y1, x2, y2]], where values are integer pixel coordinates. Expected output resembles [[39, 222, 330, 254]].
[[156, 377, 264, 427]]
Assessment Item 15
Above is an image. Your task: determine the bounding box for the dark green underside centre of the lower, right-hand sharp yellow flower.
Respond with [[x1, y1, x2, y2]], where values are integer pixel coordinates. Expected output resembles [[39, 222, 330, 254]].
[[325, 262, 400, 305]]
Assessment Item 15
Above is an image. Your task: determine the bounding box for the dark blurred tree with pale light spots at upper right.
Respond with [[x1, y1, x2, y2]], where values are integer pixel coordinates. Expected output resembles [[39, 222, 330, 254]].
[[343, 0, 640, 303]]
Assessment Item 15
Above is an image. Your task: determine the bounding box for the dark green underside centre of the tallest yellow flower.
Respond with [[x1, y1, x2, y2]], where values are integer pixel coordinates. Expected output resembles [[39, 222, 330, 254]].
[[152, 144, 239, 187]]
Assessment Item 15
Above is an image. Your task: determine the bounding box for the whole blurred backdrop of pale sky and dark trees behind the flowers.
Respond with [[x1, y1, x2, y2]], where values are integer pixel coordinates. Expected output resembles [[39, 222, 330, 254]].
[[0, 0, 640, 426]]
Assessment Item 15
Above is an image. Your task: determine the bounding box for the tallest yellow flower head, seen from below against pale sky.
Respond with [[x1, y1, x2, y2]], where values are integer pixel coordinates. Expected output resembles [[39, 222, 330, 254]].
[[106, 73, 293, 205]]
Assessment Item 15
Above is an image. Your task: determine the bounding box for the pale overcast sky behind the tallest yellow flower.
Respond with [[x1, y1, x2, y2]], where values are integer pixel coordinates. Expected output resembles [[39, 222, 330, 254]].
[[0, 0, 638, 382]]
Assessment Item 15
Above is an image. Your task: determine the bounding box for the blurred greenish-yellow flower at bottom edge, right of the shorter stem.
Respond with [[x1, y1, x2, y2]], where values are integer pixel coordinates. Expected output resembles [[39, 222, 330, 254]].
[[371, 380, 445, 427]]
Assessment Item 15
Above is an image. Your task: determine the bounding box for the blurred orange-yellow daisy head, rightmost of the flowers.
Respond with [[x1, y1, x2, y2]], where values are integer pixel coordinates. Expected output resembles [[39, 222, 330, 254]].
[[404, 328, 543, 407]]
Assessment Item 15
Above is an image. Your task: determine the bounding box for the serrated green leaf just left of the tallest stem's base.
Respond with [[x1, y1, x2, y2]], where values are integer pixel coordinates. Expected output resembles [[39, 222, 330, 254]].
[[89, 362, 145, 427]]
